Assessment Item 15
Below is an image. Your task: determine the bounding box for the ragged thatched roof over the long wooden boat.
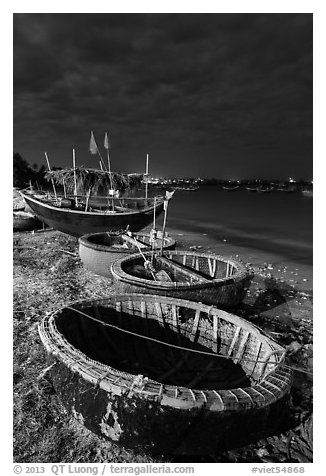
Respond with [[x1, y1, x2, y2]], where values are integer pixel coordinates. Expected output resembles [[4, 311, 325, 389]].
[[45, 167, 143, 194]]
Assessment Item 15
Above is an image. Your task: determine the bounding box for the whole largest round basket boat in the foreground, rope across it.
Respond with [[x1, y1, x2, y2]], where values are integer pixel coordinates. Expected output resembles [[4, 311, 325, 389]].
[[39, 294, 292, 454]]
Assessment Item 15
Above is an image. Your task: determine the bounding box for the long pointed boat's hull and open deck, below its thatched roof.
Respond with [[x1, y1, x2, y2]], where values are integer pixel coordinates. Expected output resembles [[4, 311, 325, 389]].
[[21, 192, 172, 237]]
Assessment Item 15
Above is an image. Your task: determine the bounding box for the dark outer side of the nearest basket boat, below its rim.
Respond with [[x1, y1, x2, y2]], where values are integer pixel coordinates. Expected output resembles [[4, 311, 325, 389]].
[[47, 357, 288, 455]]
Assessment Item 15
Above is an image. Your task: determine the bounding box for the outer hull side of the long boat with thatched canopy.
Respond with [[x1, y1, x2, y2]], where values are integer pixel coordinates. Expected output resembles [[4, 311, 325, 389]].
[[23, 194, 163, 237]]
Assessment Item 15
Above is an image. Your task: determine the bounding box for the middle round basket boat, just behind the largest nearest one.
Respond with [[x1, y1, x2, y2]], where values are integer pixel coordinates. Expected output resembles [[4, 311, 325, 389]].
[[111, 251, 252, 308]]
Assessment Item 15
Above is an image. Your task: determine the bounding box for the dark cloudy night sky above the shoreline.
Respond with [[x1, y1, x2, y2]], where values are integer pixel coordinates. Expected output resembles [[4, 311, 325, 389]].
[[13, 13, 313, 179]]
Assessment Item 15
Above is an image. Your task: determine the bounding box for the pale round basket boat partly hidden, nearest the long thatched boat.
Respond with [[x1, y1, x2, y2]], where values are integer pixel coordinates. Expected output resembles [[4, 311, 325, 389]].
[[78, 232, 176, 277]]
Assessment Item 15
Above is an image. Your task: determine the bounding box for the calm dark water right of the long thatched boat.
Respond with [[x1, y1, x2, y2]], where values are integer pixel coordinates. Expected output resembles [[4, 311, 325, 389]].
[[162, 186, 313, 264]]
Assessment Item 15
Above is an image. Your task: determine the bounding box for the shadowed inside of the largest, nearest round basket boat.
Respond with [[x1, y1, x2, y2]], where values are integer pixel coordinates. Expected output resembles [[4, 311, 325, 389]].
[[56, 298, 278, 390]]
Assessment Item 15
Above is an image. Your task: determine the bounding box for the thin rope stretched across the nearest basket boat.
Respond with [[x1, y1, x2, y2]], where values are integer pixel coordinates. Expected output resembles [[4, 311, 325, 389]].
[[66, 306, 312, 375]]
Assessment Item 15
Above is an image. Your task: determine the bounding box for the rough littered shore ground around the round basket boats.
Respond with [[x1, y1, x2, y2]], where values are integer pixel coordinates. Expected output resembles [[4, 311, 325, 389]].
[[13, 229, 313, 463]]
